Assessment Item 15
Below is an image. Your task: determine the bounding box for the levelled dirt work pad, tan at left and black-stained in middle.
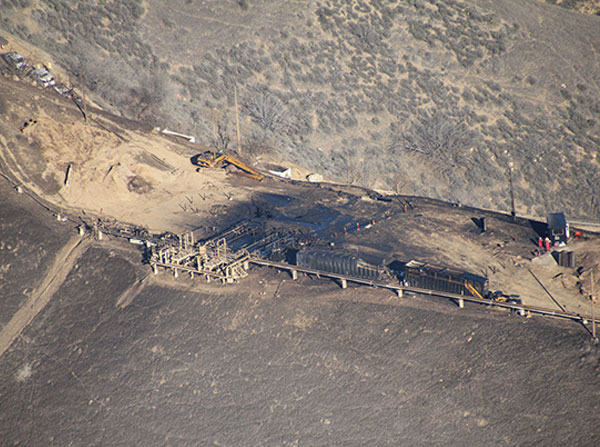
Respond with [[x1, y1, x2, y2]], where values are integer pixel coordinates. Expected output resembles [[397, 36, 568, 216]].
[[0, 72, 600, 314]]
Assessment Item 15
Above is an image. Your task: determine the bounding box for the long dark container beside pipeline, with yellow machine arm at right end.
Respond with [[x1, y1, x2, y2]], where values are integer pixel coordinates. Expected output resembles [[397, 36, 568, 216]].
[[400, 261, 488, 297]]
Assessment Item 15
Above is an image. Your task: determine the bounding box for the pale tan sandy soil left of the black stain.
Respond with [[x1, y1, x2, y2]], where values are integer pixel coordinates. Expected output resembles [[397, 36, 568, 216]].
[[0, 75, 255, 232]]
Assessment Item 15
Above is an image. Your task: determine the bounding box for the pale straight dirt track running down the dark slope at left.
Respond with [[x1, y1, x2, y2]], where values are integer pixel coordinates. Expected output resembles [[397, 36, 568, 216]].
[[0, 236, 92, 357]]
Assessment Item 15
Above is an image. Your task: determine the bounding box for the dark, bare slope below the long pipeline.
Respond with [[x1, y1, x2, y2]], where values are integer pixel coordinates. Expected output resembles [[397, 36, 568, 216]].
[[0, 180, 600, 446]]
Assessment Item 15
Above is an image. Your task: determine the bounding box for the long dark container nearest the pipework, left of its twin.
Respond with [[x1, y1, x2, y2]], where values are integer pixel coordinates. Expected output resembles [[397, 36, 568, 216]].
[[296, 249, 385, 280]]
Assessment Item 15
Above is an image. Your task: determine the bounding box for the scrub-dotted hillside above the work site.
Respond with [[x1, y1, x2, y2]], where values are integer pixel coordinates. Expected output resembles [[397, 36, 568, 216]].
[[0, 0, 600, 220]]
